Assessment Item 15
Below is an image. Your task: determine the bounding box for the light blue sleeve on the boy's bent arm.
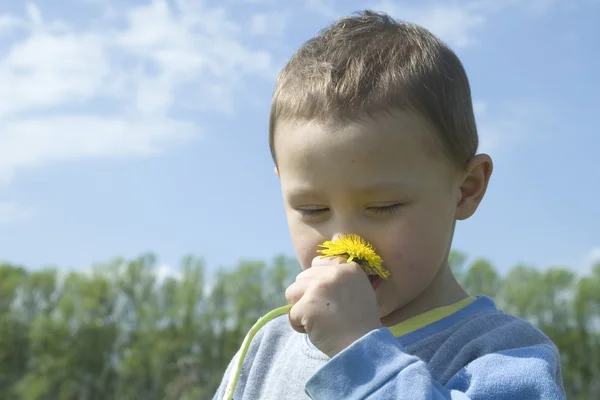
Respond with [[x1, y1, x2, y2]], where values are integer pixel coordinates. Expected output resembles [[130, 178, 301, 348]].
[[306, 328, 565, 400]]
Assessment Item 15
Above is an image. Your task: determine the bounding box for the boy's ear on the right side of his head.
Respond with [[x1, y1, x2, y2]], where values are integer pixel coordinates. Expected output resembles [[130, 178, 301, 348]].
[[456, 154, 494, 220]]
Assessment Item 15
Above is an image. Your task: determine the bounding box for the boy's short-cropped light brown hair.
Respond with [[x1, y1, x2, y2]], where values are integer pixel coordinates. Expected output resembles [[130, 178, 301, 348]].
[[269, 10, 478, 165]]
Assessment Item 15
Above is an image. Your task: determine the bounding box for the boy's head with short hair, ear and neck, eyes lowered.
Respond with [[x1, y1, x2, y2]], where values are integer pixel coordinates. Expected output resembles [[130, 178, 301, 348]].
[[270, 12, 492, 322]]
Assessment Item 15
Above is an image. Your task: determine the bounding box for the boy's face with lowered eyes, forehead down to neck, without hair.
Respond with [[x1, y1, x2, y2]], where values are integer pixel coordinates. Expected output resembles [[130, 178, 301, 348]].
[[275, 112, 489, 319]]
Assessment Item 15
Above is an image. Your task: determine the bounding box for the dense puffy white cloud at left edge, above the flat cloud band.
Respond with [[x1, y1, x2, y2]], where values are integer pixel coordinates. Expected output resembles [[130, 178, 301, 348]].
[[0, 31, 110, 116]]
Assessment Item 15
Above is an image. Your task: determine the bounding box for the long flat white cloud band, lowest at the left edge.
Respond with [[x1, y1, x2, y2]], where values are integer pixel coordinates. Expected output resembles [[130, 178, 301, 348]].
[[0, 115, 197, 183]]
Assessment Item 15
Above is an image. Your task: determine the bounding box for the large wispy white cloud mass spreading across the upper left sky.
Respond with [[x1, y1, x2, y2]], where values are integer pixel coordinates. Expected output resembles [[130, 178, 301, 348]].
[[0, 0, 275, 184]]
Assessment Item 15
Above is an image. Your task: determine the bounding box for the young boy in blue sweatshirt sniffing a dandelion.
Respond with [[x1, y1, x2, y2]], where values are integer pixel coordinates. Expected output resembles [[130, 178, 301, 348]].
[[215, 12, 564, 400]]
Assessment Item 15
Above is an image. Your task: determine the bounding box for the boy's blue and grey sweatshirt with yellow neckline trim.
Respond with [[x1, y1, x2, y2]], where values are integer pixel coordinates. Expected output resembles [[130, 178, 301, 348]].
[[213, 296, 565, 400]]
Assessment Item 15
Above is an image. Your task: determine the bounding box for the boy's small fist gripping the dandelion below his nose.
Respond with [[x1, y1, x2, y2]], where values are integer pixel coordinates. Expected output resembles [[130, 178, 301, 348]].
[[285, 257, 382, 357]]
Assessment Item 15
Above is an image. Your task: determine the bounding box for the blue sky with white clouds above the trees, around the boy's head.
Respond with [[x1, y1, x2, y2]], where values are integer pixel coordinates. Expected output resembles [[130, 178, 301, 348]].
[[0, 0, 600, 273]]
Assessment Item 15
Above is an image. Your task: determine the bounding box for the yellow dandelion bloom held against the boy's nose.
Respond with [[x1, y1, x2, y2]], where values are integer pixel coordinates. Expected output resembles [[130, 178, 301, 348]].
[[317, 233, 390, 279]]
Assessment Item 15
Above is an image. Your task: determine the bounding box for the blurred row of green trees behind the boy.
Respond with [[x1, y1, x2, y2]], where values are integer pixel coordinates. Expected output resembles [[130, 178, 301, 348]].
[[0, 251, 600, 400]]
